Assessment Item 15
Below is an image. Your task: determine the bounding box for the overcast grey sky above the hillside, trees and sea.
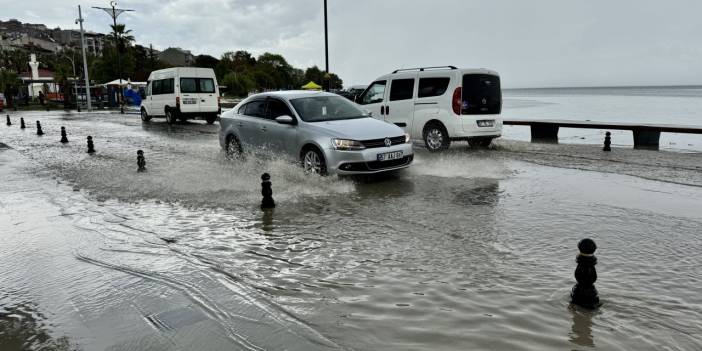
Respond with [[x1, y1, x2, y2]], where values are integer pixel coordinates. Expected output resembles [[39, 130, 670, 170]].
[[0, 0, 702, 88]]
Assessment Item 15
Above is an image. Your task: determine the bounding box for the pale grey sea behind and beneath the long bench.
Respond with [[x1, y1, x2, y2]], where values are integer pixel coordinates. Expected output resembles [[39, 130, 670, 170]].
[[502, 86, 702, 152]]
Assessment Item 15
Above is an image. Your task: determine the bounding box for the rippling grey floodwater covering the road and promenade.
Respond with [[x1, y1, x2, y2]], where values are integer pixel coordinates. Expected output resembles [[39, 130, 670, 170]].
[[0, 112, 702, 350]]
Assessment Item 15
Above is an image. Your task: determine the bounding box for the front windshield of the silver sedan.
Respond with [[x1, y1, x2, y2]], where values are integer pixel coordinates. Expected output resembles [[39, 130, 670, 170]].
[[290, 96, 366, 122]]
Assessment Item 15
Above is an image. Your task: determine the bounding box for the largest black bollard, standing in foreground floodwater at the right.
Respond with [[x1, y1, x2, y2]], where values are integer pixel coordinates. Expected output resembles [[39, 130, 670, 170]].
[[570, 239, 602, 310]]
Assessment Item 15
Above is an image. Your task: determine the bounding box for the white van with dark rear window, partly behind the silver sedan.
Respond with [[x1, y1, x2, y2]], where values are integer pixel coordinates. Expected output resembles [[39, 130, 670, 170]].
[[356, 66, 502, 152]]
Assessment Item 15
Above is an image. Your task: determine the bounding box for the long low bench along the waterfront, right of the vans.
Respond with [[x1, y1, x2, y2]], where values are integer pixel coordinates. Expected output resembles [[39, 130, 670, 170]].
[[503, 119, 702, 150]]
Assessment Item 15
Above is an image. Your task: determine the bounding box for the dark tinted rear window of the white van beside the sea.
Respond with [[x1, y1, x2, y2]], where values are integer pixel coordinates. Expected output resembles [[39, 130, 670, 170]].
[[461, 74, 502, 115]]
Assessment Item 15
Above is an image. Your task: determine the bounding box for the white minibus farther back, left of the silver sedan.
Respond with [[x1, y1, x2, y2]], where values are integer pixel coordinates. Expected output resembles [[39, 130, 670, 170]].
[[141, 67, 221, 124]]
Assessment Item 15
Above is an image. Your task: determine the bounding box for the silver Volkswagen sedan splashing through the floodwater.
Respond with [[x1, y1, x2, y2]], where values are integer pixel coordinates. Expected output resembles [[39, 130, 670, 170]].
[[219, 91, 414, 175]]
